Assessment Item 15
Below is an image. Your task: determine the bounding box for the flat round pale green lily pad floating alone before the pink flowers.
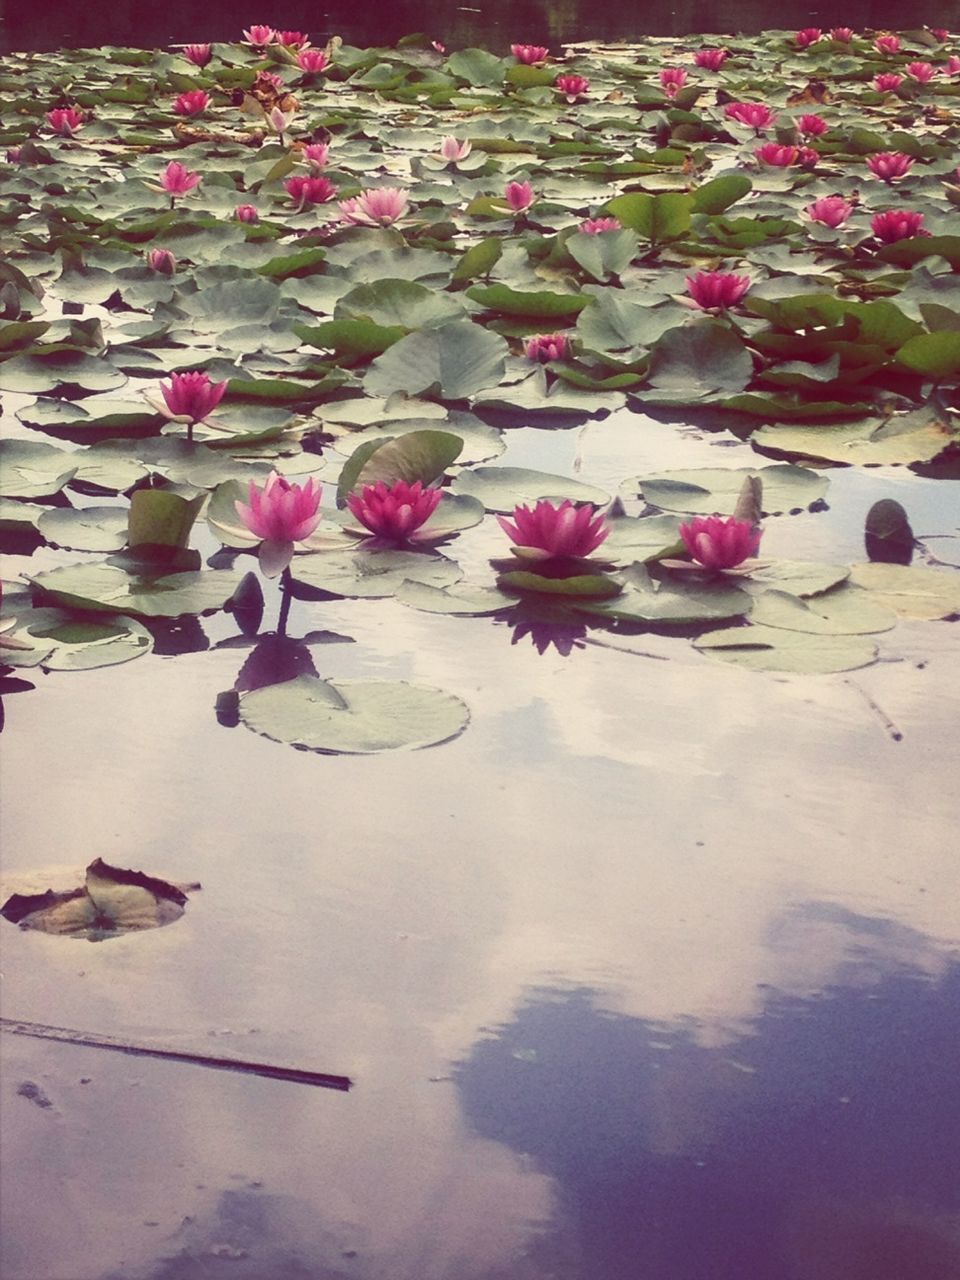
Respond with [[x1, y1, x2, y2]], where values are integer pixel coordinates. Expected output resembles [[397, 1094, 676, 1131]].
[[239, 676, 470, 755]]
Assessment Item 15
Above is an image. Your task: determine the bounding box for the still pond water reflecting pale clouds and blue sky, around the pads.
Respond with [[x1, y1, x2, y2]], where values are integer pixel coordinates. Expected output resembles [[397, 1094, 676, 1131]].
[[0, 413, 960, 1280]]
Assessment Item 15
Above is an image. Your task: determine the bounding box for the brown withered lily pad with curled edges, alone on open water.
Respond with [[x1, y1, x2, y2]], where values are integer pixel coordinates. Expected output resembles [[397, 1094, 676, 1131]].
[[0, 858, 200, 942]]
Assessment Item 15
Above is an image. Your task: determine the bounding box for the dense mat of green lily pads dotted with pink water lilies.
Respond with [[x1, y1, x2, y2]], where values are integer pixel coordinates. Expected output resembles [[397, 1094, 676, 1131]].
[[0, 28, 960, 751]]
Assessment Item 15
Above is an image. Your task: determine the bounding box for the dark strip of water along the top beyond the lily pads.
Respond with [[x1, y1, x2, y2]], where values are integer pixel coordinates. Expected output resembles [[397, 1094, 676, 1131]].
[[0, 0, 960, 52]]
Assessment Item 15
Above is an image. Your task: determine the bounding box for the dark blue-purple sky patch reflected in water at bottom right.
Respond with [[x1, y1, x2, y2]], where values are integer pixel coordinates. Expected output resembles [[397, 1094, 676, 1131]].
[[457, 906, 960, 1280]]
